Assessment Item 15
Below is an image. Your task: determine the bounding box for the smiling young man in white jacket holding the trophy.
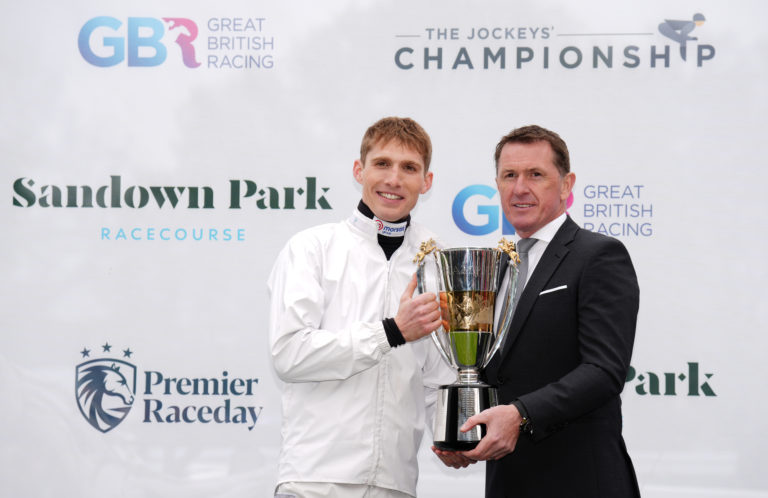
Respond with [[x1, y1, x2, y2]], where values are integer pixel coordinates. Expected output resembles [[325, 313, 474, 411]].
[[269, 118, 455, 498]]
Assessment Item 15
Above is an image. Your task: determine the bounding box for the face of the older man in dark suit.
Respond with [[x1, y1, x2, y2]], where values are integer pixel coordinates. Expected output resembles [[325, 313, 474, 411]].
[[496, 141, 576, 238]]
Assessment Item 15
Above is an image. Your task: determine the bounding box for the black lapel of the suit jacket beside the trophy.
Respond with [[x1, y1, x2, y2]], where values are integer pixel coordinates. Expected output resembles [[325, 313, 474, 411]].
[[501, 216, 579, 361]]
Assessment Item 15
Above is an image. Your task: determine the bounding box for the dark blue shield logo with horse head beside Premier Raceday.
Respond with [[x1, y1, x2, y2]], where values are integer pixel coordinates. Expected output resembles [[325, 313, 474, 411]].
[[75, 358, 136, 432]]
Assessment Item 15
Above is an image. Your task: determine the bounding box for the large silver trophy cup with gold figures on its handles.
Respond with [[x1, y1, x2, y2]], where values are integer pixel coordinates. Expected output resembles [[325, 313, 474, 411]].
[[415, 239, 520, 451]]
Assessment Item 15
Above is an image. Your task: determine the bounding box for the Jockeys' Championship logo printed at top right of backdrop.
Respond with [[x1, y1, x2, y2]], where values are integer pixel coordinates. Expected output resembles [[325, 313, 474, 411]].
[[394, 14, 716, 71]]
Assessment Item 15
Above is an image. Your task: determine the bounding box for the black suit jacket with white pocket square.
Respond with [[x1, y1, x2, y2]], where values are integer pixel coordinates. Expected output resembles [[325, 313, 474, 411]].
[[485, 217, 640, 498]]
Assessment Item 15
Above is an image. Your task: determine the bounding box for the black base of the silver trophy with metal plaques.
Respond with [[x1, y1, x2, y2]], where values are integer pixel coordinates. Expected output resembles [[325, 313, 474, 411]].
[[434, 383, 499, 451]]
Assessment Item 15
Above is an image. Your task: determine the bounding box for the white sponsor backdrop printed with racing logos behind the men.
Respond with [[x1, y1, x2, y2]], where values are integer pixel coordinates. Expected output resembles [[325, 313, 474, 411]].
[[0, 0, 768, 498]]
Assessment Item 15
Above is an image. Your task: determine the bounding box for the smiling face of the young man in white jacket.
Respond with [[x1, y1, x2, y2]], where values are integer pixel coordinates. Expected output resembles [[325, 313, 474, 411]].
[[352, 140, 432, 221]]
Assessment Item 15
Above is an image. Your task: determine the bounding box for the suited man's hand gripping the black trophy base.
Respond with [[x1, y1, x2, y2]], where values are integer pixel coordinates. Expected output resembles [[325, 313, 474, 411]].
[[459, 405, 523, 460]]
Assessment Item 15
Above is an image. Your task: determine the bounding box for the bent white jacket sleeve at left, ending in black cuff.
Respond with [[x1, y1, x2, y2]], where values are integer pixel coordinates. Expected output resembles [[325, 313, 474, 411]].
[[268, 232, 390, 382]]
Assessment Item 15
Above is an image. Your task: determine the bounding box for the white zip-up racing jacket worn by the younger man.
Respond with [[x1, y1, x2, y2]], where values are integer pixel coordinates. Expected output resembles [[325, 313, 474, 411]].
[[269, 210, 456, 496]]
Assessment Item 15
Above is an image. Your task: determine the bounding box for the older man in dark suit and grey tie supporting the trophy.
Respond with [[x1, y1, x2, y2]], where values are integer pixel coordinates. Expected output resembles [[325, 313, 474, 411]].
[[435, 126, 640, 498]]
